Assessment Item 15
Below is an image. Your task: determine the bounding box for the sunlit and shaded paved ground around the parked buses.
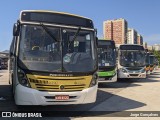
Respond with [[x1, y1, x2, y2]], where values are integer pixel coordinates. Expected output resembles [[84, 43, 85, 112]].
[[0, 70, 160, 120]]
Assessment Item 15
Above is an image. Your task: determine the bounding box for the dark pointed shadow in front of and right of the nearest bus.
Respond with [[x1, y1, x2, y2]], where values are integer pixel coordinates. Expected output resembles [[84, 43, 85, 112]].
[[7, 90, 145, 117]]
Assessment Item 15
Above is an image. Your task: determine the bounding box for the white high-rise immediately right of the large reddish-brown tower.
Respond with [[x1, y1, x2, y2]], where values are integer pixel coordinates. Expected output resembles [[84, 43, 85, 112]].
[[127, 28, 137, 44]]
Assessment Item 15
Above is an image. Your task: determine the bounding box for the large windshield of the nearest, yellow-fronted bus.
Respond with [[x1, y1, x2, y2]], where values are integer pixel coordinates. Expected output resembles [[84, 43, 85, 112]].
[[19, 25, 96, 72]]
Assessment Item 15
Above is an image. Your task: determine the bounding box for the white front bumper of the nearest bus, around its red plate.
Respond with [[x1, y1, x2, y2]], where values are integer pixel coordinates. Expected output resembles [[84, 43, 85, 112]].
[[15, 84, 98, 105]]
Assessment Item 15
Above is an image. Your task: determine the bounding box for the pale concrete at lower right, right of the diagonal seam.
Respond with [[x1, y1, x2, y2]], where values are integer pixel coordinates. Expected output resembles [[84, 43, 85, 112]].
[[76, 69, 160, 120]]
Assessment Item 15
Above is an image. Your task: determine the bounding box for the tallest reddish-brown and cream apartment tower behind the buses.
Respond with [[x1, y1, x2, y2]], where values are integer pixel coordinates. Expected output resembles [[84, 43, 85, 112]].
[[103, 18, 128, 46]]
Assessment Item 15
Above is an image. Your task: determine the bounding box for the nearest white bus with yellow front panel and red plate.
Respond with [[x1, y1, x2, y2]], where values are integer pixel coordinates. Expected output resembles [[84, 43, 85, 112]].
[[9, 10, 98, 105]]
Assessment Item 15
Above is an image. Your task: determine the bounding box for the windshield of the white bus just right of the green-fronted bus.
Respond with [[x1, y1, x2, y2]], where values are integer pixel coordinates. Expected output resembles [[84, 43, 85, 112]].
[[120, 50, 145, 67]]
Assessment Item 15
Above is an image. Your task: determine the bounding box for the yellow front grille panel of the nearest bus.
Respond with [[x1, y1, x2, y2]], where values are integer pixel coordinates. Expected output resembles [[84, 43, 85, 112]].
[[27, 76, 91, 92]]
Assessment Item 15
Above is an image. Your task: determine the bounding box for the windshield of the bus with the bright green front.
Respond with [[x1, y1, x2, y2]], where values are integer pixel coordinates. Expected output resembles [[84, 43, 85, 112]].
[[98, 45, 116, 66]]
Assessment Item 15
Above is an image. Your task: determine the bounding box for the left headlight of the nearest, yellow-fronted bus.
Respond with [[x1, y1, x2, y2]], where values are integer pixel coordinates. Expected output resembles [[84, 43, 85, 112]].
[[17, 68, 30, 87]]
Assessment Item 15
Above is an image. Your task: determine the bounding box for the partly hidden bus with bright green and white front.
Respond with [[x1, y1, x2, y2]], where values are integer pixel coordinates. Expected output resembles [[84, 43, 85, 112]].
[[98, 39, 117, 83]]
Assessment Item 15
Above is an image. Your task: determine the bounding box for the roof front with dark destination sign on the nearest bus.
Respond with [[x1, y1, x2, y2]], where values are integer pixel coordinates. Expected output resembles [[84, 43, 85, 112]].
[[20, 10, 94, 29]]
